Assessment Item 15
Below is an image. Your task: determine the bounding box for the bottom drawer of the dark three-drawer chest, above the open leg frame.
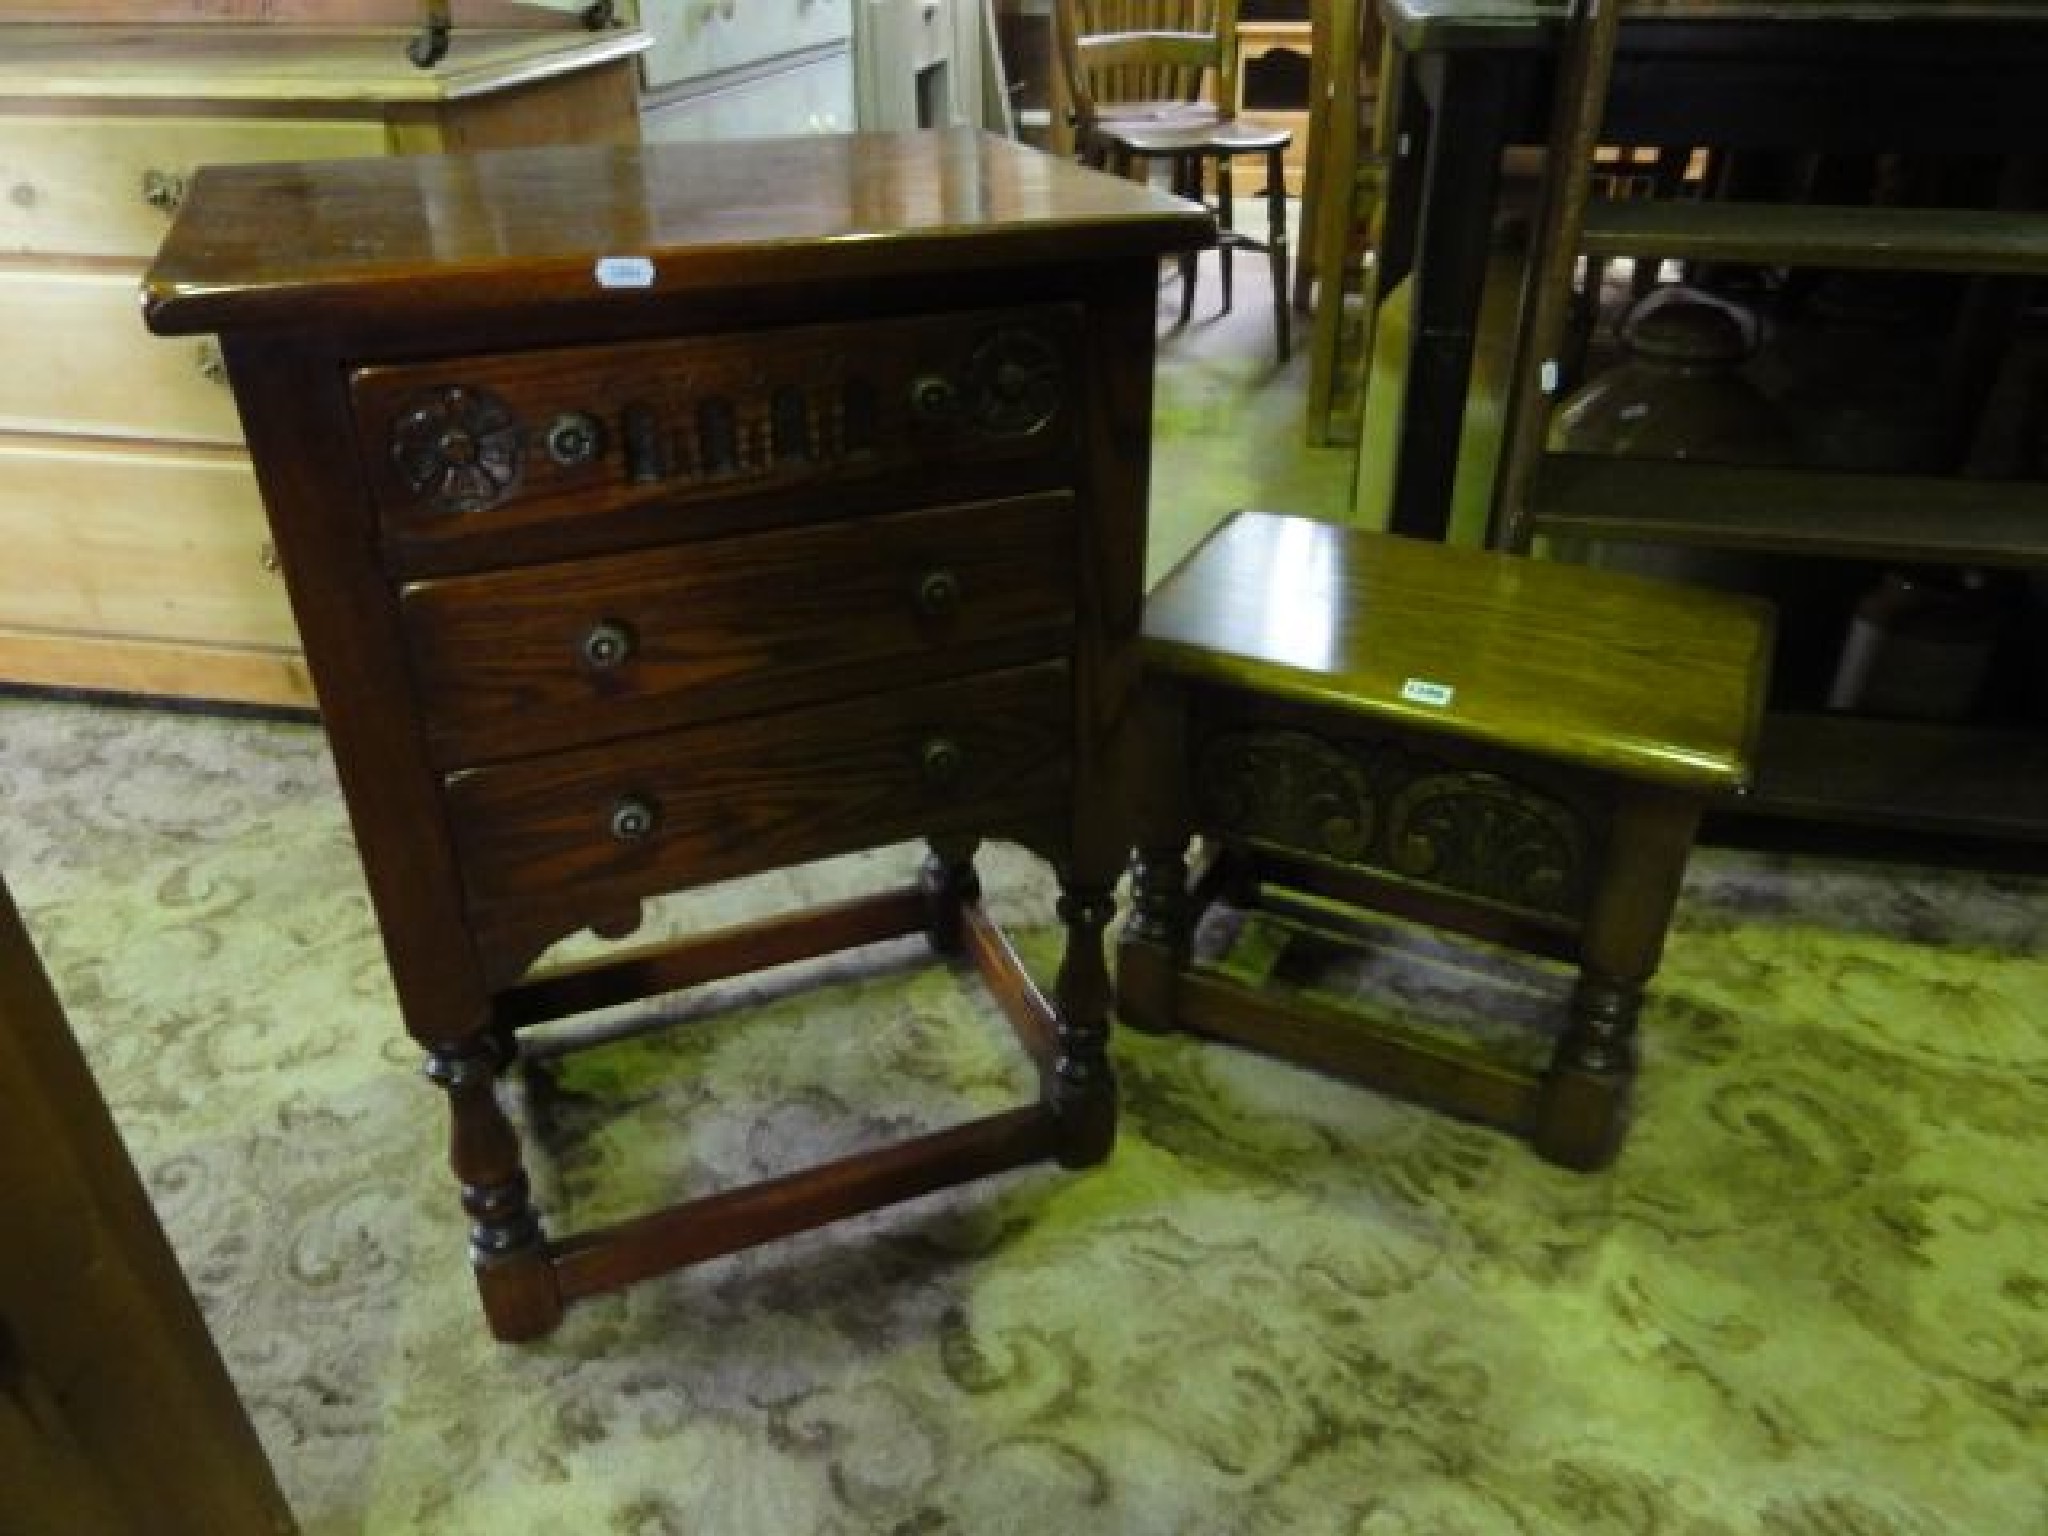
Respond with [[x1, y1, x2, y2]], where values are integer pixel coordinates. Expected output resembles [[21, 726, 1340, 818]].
[[446, 662, 1073, 915]]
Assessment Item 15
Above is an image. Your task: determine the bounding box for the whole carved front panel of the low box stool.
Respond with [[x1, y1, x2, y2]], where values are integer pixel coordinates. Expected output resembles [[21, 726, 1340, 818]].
[[1194, 729, 1593, 915]]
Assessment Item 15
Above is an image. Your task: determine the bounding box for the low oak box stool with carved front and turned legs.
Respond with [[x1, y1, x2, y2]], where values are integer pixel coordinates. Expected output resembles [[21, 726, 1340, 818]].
[[1118, 512, 1772, 1167]]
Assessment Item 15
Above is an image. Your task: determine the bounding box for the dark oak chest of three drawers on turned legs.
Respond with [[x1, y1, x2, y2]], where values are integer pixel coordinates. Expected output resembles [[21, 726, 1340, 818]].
[[145, 131, 1208, 1337]]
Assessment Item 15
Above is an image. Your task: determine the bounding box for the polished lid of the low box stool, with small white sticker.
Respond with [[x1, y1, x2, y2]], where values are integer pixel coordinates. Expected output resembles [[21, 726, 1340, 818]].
[[1145, 512, 1772, 791]]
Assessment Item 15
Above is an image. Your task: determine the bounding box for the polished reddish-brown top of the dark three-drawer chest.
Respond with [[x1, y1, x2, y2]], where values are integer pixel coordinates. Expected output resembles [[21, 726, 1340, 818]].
[[143, 129, 1214, 334]]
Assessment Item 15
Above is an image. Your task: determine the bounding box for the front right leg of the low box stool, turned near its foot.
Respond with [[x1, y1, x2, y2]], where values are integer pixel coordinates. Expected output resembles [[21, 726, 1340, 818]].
[[1530, 791, 1700, 1169]]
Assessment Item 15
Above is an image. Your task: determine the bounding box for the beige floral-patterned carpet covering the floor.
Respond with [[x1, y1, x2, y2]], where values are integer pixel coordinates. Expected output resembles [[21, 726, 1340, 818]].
[[0, 700, 2048, 1536]]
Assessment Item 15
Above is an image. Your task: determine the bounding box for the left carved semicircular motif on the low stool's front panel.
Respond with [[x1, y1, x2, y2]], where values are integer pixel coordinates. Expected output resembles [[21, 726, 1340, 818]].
[[1194, 731, 1378, 860]]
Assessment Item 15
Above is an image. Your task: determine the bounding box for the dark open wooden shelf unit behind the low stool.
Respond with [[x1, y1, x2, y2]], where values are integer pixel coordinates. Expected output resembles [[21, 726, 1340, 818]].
[[1493, 6, 2048, 850]]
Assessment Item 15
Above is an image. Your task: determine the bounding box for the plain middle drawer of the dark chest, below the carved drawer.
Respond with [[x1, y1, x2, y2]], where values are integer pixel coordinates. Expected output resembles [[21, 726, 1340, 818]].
[[401, 492, 1075, 768]]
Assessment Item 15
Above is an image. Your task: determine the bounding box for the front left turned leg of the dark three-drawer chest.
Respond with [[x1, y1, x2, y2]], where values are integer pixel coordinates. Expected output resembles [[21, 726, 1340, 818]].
[[426, 1032, 561, 1339]]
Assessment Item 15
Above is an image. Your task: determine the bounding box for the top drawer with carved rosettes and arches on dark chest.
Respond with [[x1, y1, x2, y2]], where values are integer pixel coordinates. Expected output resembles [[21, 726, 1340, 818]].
[[352, 307, 1079, 567]]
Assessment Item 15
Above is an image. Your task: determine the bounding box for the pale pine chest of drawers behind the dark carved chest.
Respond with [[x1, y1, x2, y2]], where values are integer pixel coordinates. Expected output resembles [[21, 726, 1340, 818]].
[[0, 16, 645, 707]]
